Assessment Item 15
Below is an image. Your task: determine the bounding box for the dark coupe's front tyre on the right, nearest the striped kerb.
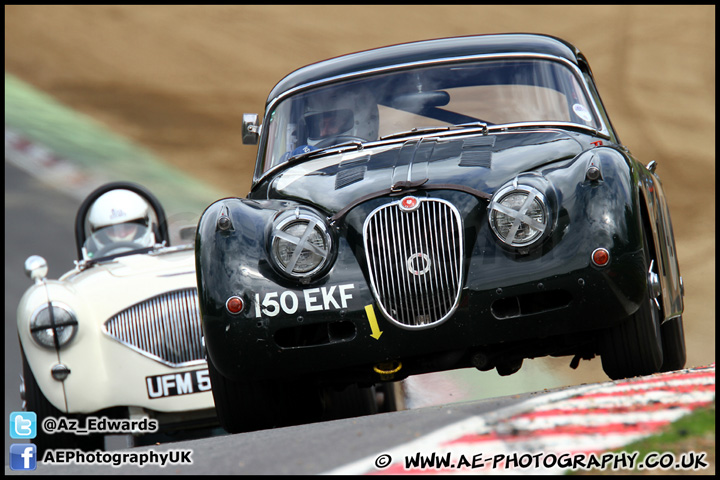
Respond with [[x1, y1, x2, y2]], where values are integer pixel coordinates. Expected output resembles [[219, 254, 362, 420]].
[[600, 231, 663, 380]]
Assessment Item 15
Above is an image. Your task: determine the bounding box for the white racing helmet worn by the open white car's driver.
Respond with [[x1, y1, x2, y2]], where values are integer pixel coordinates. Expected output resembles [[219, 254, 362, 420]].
[[88, 190, 155, 247]]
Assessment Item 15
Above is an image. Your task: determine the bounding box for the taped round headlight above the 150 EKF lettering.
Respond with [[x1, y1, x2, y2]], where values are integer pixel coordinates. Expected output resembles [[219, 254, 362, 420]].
[[268, 207, 333, 281]]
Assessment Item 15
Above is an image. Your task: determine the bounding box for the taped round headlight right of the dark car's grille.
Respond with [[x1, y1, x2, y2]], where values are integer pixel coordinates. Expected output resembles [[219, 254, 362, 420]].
[[489, 185, 549, 247]]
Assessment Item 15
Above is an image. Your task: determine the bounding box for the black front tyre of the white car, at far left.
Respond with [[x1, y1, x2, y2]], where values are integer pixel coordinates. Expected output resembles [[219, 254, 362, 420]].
[[20, 346, 105, 459]]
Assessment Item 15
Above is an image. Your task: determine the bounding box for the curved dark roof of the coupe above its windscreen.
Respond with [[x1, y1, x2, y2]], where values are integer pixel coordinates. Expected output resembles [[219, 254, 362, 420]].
[[267, 33, 582, 104]]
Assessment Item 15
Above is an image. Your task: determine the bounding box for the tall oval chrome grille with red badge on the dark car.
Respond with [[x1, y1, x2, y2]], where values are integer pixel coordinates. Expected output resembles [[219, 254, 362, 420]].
[[363, 197, 463, 328]]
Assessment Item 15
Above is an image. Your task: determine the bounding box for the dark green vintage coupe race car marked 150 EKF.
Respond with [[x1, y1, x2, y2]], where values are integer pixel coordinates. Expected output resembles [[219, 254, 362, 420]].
[[196, 34, 685, 432]]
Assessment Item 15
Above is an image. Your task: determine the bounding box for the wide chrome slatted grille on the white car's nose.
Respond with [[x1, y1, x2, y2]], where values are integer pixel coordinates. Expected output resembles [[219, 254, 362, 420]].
[[105, 288, 204, 367]]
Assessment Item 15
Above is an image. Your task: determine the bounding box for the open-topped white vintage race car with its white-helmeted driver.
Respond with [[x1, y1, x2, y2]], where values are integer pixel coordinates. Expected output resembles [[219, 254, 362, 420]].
[[17, 182, 217, 452]]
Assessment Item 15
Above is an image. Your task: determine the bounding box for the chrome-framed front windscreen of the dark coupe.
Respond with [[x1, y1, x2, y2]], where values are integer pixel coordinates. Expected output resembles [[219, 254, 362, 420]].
[[262, 58, 600, 171]]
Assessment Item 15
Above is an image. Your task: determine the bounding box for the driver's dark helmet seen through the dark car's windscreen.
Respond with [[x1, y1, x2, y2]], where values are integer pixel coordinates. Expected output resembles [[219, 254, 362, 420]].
[[303, 86, 379, 146]]
